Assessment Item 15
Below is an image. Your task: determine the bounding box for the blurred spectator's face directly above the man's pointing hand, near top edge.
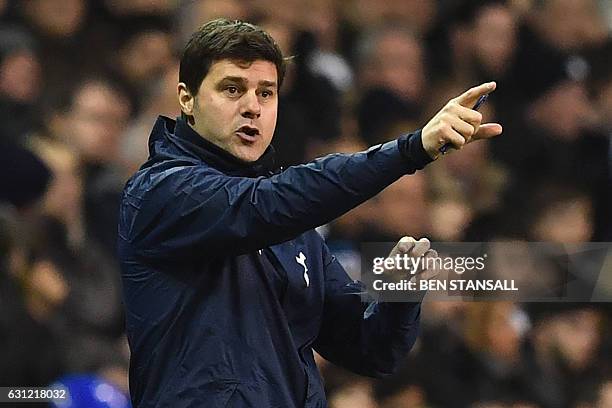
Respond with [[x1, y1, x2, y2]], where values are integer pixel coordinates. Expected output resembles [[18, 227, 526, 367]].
[[472, 5, 517, 74]]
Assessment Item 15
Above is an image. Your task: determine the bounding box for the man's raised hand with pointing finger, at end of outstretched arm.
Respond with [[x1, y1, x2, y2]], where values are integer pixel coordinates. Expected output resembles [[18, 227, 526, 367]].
[[421, 82, 502, 159]]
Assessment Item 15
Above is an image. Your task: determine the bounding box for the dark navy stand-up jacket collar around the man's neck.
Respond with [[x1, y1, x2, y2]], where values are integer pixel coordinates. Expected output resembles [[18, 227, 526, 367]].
[[151, 116, 276, 177]]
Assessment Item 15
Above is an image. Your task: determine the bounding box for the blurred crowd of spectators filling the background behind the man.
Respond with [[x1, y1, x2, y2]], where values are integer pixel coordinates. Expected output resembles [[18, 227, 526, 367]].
[[0, 0, 612, 408]]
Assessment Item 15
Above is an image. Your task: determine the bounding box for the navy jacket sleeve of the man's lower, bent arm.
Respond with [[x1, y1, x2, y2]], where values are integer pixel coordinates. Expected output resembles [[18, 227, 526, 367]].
[[313, 244, 421, 378]]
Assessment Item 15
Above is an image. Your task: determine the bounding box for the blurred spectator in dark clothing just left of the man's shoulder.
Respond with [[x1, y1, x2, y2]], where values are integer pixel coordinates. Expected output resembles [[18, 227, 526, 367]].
[[55, 78, 131, 257]]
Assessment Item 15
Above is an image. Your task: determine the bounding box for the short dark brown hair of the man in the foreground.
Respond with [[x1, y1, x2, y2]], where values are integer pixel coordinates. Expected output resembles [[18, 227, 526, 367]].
[[179, 18, 285, 95]]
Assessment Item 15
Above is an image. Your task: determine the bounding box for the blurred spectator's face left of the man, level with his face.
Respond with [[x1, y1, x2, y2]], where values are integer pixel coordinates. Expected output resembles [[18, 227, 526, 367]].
[[66, 82, 130, 163]]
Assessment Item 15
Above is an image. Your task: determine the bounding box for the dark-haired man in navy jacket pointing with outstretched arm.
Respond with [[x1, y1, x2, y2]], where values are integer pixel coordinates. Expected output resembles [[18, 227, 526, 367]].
[[119, 20, 501, 407]]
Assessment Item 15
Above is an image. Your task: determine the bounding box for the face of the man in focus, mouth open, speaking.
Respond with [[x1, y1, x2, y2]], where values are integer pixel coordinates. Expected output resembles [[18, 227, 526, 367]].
[[179, 59, 278, 162]]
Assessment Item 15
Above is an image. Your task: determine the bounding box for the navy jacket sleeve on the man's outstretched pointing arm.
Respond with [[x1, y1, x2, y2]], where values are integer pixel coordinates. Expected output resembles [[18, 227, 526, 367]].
[[119, 131, 431, 258]]
